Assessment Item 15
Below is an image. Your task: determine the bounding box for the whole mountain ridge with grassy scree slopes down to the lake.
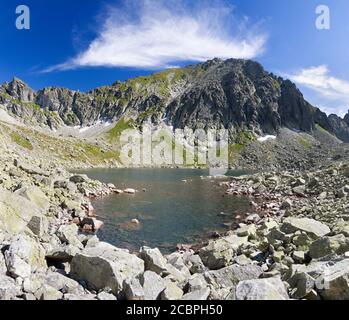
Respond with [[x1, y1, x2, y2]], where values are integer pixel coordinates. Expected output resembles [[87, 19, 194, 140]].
[[0, 59, 349, 170]]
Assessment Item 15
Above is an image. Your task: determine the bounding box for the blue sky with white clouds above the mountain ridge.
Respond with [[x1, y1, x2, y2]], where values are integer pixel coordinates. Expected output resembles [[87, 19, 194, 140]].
[[0, 0, 349, 114]]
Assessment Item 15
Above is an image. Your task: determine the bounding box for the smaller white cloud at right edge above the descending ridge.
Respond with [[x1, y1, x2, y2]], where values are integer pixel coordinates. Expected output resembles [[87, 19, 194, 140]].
[[289, 65, 349, 115]]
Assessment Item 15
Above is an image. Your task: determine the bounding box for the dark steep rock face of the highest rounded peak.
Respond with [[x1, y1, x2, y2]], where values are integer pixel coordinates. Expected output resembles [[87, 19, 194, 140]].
[[167, 60, 281, 132]]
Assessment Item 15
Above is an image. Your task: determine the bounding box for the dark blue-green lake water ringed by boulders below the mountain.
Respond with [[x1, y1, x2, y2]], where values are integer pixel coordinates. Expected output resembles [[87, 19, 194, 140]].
[[80, 169, 249, 252]]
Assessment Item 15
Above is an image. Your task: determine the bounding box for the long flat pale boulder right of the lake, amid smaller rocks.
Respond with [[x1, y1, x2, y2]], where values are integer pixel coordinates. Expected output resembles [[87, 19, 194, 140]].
[[281, 217, 331, 239]]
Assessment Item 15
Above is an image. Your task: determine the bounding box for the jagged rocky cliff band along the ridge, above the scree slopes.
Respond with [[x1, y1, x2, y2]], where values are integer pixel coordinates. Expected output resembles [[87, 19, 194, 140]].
[[0, 59, 349, 141]]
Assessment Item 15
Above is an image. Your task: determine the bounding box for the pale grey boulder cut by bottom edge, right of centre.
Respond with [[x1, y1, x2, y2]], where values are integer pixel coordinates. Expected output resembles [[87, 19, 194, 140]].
[[236, 278, 289, 300]]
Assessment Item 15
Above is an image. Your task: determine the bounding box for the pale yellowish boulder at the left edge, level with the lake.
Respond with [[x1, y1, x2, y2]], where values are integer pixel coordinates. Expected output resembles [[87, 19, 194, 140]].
[[0, 188, 41, 234]]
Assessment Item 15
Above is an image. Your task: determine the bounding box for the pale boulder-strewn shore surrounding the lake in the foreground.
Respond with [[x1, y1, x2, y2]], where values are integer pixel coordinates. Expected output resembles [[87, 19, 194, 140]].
[[0, 155, 349, 300]]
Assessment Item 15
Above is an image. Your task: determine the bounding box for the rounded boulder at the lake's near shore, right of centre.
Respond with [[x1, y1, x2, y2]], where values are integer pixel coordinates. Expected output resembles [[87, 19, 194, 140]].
[[199, 239, 234, 270]]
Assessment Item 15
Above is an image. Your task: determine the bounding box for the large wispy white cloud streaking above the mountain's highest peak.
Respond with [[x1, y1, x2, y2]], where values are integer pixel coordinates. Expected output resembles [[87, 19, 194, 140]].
[[46, 0, 267, 72]]
